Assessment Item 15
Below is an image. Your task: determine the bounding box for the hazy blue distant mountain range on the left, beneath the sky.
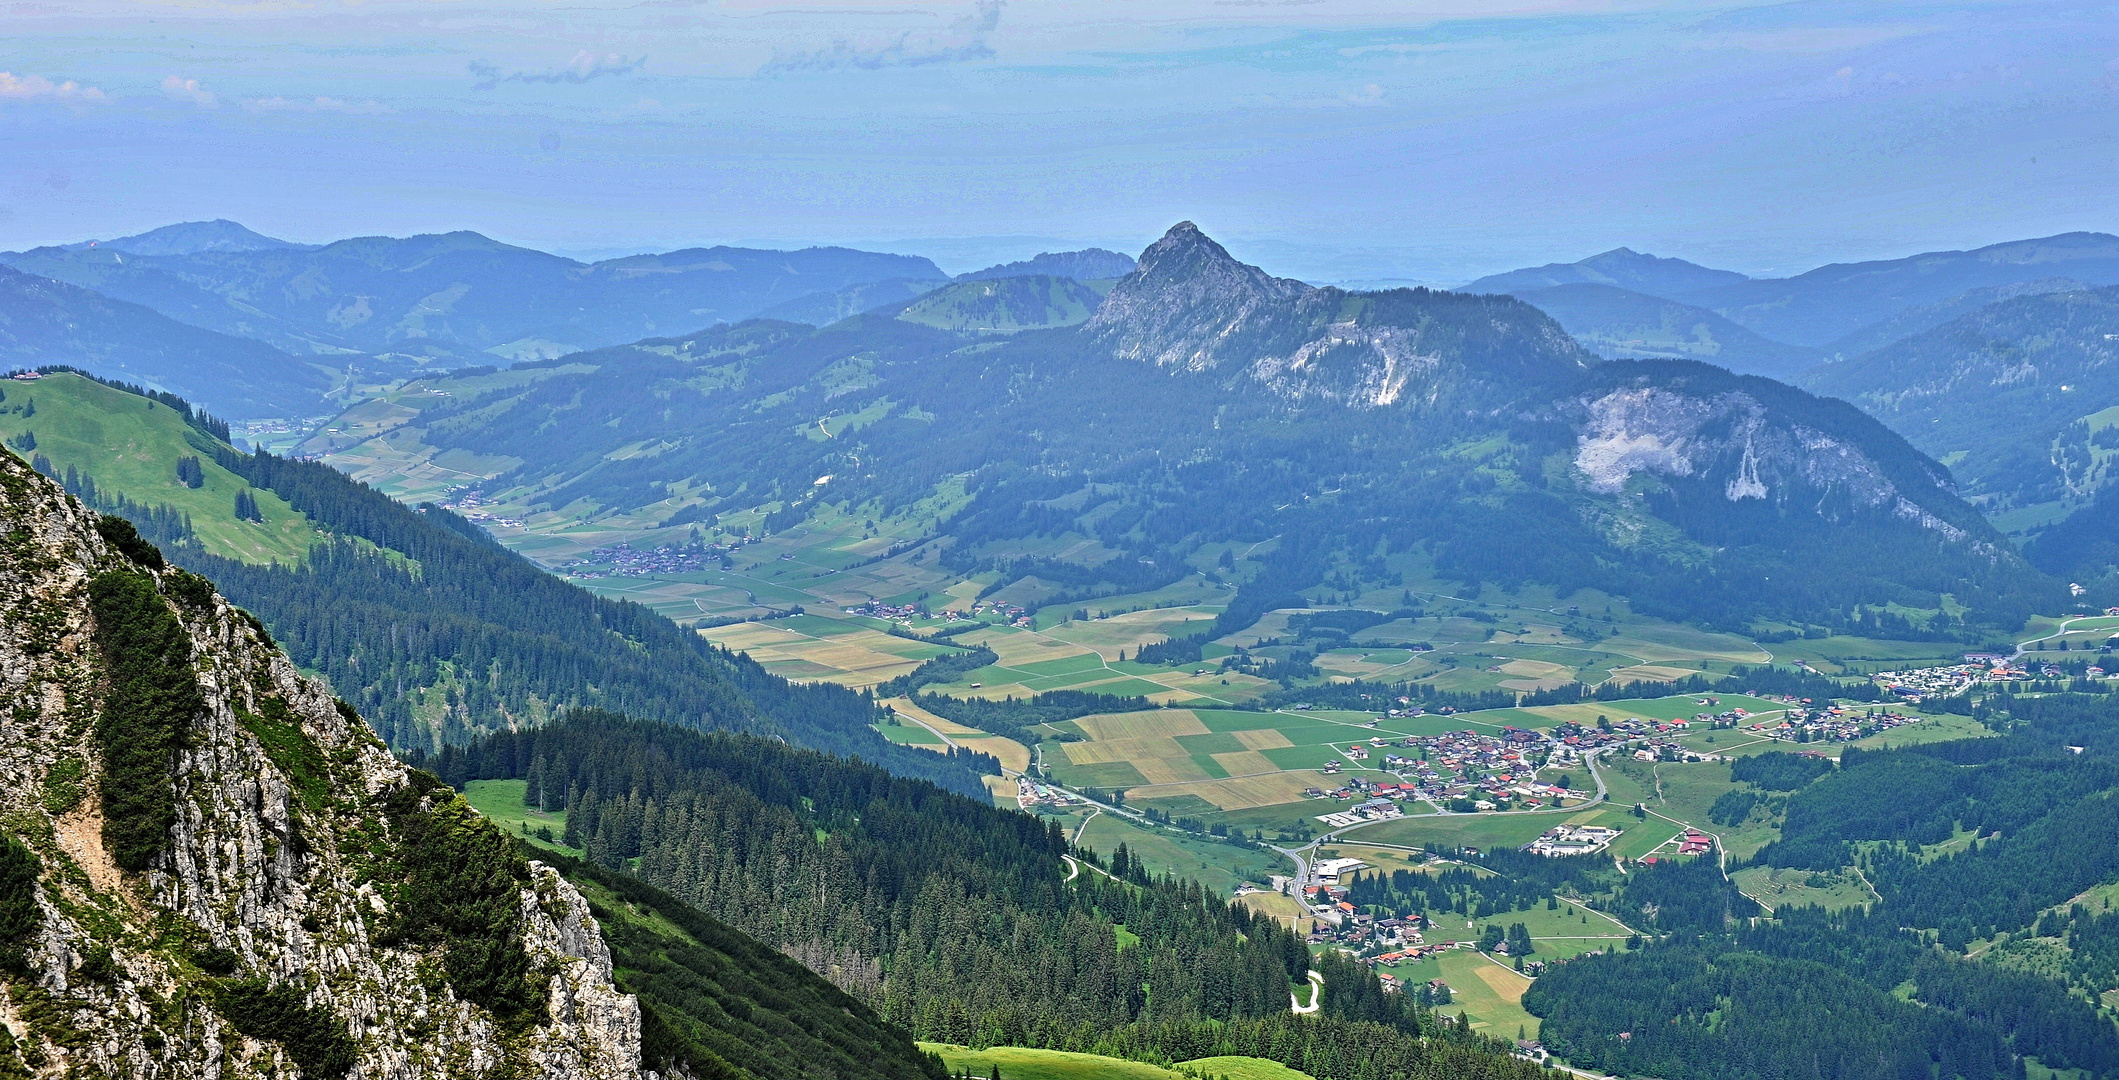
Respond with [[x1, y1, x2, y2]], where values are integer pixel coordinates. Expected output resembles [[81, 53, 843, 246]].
[[0, 233, 947, 360]]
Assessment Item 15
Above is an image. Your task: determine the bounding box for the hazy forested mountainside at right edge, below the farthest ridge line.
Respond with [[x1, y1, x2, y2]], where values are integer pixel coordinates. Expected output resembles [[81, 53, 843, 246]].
[[1799, 288, 2119, 508]]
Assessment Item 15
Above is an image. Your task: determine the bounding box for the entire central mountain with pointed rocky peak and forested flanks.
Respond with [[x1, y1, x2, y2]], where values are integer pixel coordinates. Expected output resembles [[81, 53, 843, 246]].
[[343, 224, 2058, 640]]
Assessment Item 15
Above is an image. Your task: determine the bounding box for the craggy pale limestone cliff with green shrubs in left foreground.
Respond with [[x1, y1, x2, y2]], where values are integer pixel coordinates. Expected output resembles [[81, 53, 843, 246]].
[[0, 444, 642, 1080]]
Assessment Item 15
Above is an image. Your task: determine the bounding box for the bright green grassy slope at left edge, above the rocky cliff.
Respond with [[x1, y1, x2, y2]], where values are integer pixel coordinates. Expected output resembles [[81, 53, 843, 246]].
[[0, 375, 318, 563]]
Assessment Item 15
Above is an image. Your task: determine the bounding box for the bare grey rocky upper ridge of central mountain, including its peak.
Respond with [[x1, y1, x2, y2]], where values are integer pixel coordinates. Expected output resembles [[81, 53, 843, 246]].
[[1085, 222, 1587, 409]]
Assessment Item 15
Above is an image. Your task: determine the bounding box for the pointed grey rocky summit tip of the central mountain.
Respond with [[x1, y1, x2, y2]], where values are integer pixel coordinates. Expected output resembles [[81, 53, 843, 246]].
[[1087, 220, 1314, 371]]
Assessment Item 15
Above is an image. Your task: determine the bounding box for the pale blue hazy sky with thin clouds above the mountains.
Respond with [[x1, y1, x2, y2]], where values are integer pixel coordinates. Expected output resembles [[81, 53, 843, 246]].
[[0, 0, 2119, 284]]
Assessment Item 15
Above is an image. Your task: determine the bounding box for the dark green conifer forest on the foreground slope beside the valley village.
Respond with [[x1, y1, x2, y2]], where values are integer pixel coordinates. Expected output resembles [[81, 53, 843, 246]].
[[428, 714, 1545, 1080]]
